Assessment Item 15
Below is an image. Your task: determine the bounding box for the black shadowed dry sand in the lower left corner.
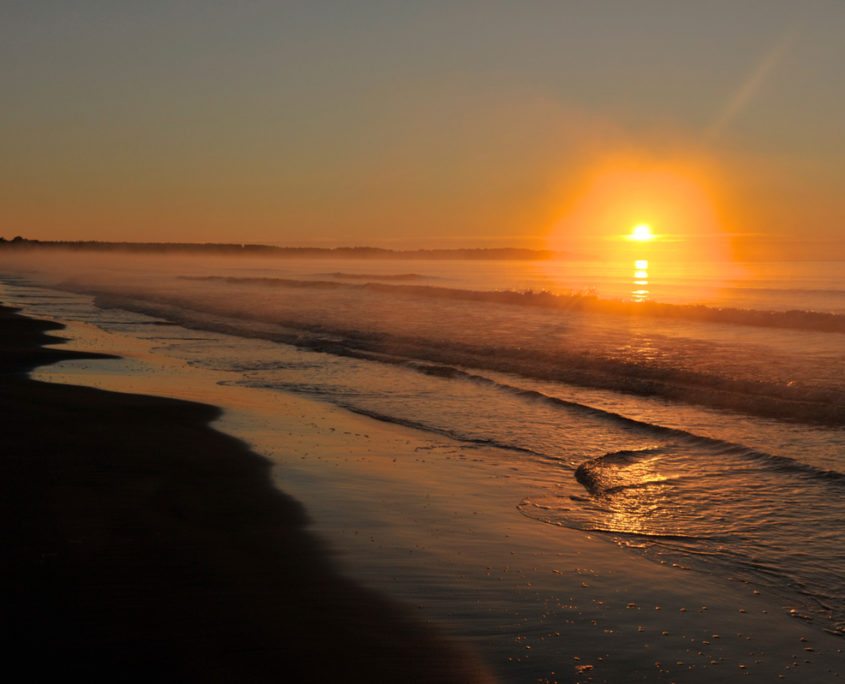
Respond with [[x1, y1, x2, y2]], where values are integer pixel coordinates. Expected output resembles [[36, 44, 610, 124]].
[[0, 307, 489, 682]]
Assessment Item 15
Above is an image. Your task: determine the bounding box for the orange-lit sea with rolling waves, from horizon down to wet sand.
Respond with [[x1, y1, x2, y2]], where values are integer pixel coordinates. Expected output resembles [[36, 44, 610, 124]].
[[0, 251, 845, 632]]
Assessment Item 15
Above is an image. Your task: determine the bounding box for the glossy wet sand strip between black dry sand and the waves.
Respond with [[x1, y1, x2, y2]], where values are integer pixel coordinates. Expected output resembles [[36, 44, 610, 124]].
[[6, 302, 843, 683]]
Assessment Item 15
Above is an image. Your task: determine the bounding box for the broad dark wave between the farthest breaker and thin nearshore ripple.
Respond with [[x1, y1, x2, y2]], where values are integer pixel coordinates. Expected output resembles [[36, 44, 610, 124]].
[[89, 290, 845, 426]]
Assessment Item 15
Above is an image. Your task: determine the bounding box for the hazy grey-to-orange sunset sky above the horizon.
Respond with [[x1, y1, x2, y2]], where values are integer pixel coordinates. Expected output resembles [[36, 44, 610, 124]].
[[0, 0, 845, 259]]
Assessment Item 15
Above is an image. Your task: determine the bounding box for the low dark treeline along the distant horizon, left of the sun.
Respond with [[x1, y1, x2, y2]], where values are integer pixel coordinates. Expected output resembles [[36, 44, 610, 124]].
[[0, 236, 565, 261]]
